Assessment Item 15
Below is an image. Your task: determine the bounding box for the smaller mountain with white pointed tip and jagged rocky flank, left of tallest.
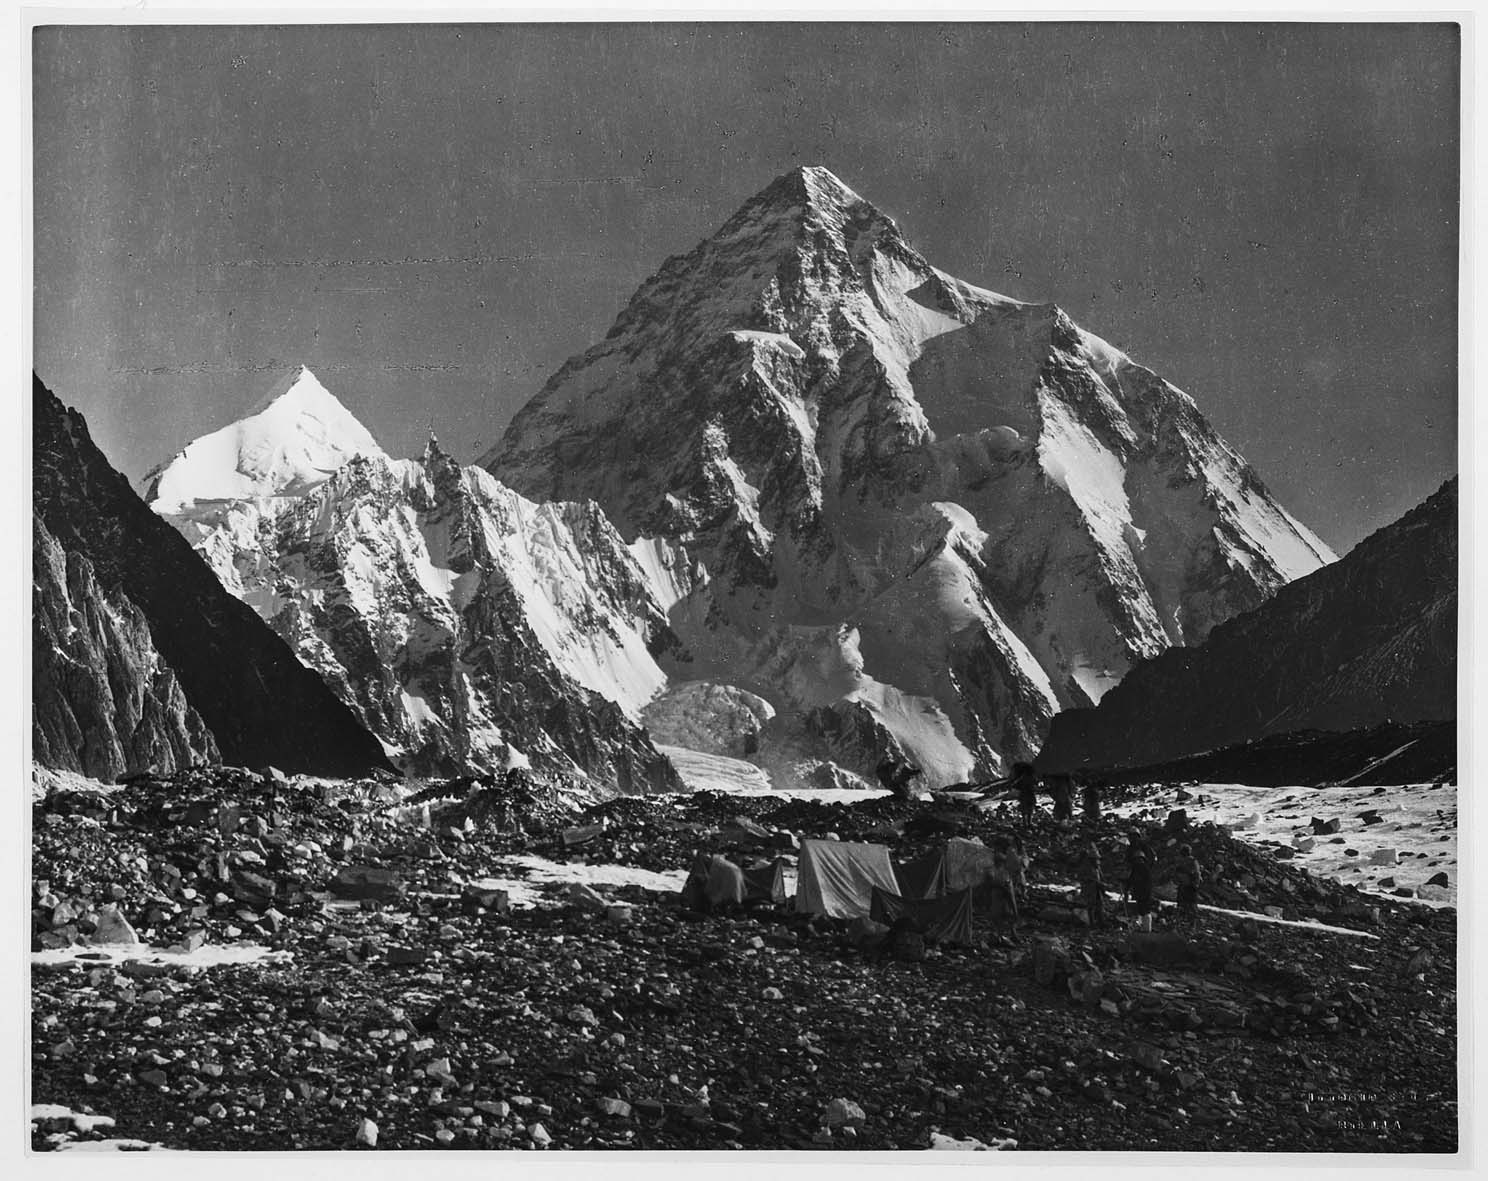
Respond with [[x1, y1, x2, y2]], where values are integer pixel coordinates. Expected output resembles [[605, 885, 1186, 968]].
[[146, 370, 679, 793]]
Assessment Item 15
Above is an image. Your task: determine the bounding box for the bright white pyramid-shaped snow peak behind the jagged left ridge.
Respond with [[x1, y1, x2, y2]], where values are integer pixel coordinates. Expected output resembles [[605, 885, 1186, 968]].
[[141, 367, 382, 513]]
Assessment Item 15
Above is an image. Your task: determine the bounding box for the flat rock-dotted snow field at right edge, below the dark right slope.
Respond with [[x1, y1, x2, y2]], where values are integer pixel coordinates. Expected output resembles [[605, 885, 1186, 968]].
[[1115, 784, 1457, 906]]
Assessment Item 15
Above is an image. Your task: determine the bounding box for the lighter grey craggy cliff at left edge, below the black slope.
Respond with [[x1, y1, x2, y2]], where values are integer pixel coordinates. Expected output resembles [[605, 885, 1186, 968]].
[[31, 515, 219, 782]]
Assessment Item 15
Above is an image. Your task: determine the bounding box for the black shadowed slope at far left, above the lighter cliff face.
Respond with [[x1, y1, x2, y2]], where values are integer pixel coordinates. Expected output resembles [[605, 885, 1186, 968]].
[[33, 368, 387, 775]]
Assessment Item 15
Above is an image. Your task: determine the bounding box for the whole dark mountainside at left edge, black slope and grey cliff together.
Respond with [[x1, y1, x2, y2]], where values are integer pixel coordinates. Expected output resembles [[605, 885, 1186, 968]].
[[31, 378, 388, 778]]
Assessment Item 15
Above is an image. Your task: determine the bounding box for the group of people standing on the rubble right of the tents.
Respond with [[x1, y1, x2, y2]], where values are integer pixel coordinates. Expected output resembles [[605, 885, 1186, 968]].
[[998, 763, 1202, 931]]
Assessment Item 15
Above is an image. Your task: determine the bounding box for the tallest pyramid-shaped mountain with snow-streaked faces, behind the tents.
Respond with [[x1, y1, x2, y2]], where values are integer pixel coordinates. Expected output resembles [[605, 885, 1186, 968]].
[[482, 161, 1332, 784]]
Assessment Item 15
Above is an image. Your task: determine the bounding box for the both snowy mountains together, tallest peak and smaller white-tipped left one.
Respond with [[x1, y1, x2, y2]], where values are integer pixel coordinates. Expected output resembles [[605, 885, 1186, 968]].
[[122, 168, 1333, 791]]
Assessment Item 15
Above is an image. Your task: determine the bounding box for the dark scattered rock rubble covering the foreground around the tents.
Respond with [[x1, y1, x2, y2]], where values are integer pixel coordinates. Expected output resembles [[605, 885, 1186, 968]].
[[31, 769, 1457, 1153]]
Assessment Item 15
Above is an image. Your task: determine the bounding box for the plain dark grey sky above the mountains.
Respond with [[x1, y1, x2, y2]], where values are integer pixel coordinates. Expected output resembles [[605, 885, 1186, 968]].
[[33, 22, 1458, 550]]
